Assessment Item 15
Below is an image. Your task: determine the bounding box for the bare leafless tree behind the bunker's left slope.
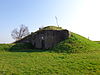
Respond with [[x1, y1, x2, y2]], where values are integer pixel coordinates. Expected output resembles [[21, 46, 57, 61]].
[[11, 24, 29, 40]]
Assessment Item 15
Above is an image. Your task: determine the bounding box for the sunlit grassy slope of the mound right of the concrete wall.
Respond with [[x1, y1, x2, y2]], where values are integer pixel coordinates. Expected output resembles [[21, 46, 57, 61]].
[[53, 33, 100, 53]]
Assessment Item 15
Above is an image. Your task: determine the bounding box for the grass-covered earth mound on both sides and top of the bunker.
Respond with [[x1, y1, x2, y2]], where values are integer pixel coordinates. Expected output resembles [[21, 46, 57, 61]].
[[0, 26, 100, 53]]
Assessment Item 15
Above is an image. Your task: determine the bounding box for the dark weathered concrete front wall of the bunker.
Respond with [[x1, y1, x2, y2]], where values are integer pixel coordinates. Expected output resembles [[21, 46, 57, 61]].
[[14, 30, 70, 49]]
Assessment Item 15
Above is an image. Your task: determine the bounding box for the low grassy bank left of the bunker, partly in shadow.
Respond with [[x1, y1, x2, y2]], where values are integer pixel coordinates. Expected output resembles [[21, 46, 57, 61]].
[[0, 43, 32, 52]]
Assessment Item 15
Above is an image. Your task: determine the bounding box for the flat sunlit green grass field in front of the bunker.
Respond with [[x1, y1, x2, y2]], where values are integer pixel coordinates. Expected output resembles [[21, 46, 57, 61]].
[[0, 51, 100, 75]]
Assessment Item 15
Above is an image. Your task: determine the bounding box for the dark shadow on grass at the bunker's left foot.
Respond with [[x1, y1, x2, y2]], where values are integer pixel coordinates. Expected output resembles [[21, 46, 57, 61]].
[[9, 43, 50, 52]]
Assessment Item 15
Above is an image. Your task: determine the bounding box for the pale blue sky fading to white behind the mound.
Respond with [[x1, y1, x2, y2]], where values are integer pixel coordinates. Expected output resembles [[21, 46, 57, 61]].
[[0, 0, 100, 43]]
